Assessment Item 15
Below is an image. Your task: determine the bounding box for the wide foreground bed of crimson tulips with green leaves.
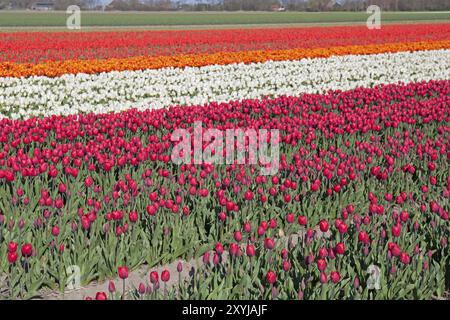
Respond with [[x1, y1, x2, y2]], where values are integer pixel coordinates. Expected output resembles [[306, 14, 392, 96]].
[[0, 80, 450, 298]]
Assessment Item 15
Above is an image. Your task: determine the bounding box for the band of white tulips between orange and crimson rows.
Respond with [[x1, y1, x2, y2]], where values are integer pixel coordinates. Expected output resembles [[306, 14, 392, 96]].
[[0, 50, 450, 119]]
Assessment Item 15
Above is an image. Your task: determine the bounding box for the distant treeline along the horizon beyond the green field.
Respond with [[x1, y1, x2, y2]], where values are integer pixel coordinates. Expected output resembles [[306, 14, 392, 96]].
[[0, 0, 450, 11]]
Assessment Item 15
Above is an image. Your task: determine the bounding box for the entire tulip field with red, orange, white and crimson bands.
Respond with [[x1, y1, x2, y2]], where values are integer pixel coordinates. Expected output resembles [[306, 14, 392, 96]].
[[0, 23, 450, 300]]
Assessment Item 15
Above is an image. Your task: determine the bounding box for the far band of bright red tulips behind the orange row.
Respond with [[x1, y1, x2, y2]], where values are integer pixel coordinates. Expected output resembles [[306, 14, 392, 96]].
[[0, 24, 450, 63]]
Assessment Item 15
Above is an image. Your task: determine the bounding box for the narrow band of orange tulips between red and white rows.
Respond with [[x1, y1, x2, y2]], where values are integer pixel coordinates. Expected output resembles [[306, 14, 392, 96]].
[[0, 40, 450, 77]]
